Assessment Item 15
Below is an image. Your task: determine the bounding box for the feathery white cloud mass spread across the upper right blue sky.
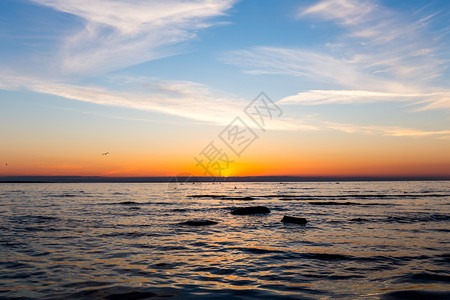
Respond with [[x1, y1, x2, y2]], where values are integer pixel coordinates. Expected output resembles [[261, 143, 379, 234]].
[[223, 0, 449, 110]]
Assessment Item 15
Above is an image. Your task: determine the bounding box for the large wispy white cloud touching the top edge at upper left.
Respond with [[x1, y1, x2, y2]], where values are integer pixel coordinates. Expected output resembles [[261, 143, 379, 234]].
[[24, 0, 234, 74]]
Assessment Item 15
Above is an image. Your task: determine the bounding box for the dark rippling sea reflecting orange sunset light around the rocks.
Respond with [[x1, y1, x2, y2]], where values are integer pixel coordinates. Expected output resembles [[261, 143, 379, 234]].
[[0, 181, 450, 299]]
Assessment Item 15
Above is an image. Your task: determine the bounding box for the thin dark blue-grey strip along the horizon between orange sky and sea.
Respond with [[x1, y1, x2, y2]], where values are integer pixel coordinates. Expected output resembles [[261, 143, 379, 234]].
[[0, 176, 450, 184]]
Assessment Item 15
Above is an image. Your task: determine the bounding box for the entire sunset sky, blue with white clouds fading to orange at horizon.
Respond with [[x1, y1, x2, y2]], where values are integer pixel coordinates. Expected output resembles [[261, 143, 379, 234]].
[[0, 0, 450, 177]]
